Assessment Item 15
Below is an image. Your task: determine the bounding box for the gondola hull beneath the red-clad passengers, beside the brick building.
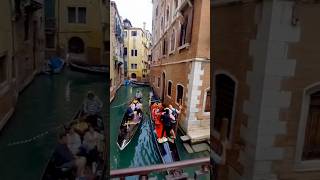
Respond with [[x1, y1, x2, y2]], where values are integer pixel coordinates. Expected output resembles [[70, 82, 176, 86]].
[[149, 95, 183, 176]]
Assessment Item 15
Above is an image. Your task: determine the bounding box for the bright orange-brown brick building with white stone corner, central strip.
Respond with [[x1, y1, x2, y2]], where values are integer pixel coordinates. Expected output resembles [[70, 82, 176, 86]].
[[150, 0, 211, 142]]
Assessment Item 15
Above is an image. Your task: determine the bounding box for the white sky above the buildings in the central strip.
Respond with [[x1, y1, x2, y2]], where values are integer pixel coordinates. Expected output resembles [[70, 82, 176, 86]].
[[114, 0, 152, 32]]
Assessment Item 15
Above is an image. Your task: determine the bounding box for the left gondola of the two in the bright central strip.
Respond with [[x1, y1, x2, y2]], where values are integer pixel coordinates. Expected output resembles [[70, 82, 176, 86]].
[[117, 99, 143, 150]]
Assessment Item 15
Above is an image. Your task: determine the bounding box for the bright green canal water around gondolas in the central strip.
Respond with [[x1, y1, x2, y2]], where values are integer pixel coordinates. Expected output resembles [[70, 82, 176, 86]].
[[110, 86, 209, 179]]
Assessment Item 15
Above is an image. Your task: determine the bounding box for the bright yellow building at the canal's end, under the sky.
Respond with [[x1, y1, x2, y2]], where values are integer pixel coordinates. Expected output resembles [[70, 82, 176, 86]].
[[124, 27, 151, 82]]
